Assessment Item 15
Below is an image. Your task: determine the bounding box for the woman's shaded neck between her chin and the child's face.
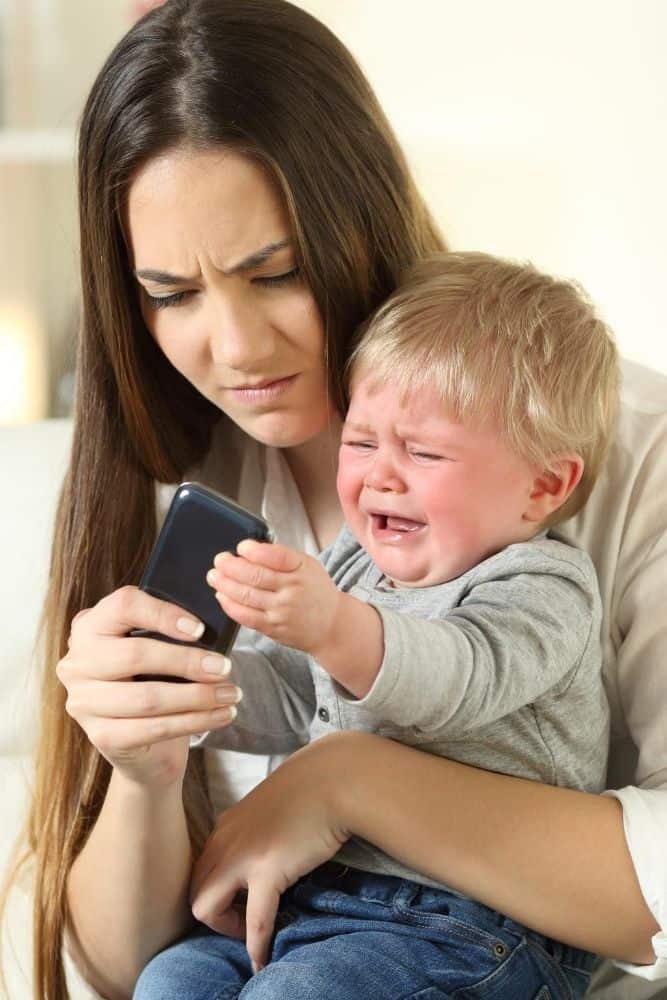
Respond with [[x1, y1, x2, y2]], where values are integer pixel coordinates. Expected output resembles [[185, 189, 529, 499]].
[[283, 417, 343, 548]]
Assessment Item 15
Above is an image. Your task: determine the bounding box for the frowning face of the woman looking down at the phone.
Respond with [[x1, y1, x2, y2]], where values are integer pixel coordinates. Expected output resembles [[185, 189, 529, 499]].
[[126, 149, 328, 447]]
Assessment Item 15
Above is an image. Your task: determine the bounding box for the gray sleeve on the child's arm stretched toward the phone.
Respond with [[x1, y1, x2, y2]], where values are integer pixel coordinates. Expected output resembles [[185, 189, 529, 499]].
[[356, 573, 599, 739]]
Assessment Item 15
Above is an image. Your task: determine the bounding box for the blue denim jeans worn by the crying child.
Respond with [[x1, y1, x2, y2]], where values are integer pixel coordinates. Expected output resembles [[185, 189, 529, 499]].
[[133, 862, 595, 1000]]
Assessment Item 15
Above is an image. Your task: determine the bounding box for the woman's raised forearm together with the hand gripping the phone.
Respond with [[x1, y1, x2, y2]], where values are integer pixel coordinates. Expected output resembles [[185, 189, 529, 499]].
[[56, 587, 237, 1000]]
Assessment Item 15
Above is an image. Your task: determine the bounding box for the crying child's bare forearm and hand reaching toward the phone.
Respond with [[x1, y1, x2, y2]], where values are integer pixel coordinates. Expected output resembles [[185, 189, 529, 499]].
[[209, 540, 384, 698]]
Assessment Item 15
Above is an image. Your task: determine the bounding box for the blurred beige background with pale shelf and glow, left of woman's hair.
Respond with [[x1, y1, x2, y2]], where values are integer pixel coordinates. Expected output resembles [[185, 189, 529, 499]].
[[0, 0, 131, 423]]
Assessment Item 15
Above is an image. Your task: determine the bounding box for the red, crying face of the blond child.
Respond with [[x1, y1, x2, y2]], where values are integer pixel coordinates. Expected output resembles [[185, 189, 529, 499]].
[[338, 375, 538, 587]]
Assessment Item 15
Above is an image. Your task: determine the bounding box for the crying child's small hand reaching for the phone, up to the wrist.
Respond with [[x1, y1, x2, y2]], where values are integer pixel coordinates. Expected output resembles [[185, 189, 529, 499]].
[[207, 539, 342, 657]]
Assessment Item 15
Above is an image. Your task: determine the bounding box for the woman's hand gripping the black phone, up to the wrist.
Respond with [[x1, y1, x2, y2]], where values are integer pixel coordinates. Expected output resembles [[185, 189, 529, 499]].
[[56, 587, 240, 784]]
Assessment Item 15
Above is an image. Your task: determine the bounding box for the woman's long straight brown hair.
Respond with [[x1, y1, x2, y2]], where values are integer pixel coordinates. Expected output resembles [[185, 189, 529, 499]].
[[3, 0, 443, 1000]]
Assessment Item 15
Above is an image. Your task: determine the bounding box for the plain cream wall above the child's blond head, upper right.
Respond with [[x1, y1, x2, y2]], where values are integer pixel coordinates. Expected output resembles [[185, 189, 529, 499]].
[[301, 0, 667, 372]]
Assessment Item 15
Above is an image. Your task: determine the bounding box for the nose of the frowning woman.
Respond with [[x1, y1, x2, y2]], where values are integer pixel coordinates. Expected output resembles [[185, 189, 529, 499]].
[[207, 295, 275, 375]]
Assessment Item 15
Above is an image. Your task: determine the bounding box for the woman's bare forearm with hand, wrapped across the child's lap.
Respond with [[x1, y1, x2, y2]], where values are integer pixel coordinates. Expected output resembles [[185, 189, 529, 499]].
[[192, 732, 658, 966]]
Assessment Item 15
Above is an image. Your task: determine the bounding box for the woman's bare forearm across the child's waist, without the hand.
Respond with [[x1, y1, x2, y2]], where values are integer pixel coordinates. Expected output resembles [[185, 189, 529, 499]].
[[332, 733, 658, 964]]
